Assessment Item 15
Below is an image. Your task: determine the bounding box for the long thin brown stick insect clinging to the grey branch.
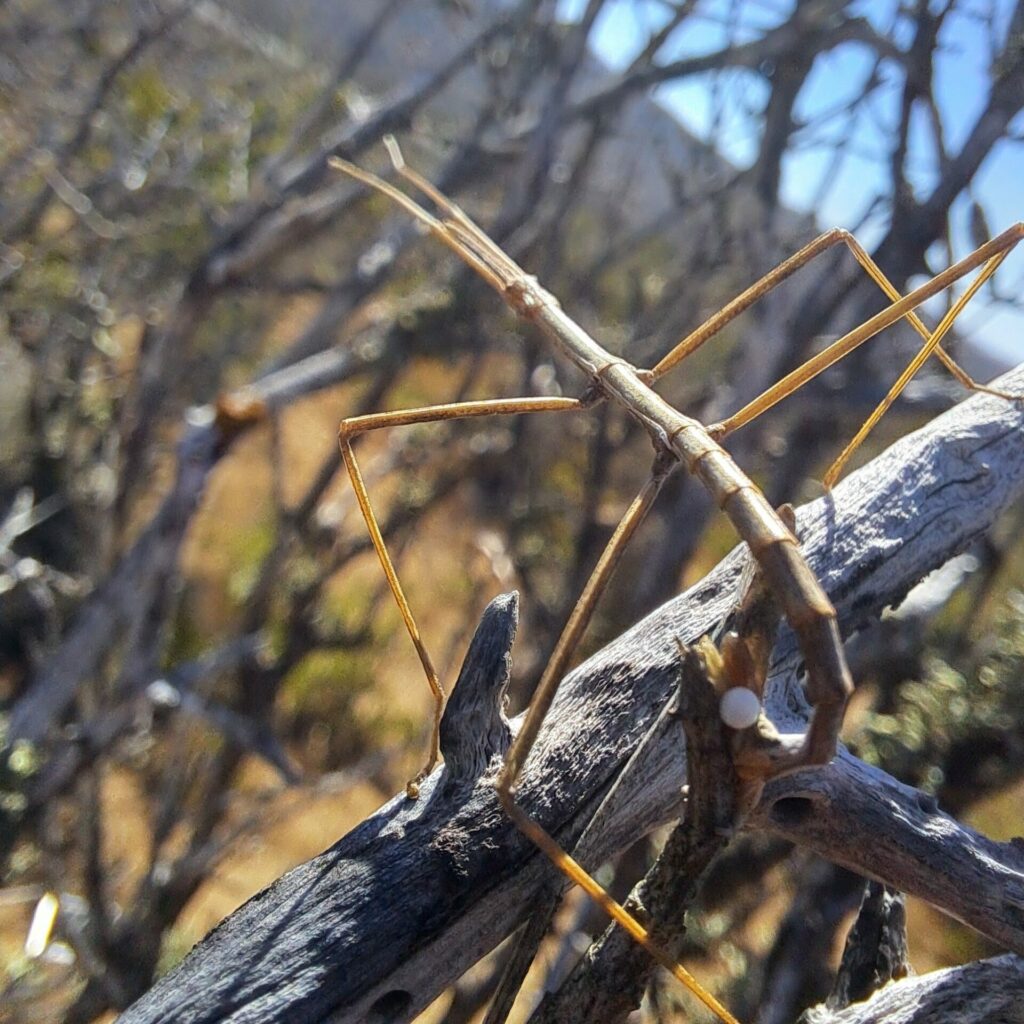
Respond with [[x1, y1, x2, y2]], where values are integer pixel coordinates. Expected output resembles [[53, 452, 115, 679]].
[[331, 139, 1024, 1024]]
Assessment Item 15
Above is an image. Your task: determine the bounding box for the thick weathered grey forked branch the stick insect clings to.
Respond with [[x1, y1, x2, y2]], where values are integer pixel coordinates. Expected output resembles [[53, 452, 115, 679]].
[[122, 369, 1024, 1024]]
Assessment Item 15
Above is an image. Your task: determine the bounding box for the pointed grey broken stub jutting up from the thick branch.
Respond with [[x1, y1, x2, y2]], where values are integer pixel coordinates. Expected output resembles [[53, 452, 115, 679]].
[[440, 591, 519, 791]]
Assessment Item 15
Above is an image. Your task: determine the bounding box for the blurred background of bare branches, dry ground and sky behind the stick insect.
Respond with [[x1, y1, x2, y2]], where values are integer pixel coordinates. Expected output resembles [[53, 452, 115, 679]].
[[0, 0, 1024, 1022]]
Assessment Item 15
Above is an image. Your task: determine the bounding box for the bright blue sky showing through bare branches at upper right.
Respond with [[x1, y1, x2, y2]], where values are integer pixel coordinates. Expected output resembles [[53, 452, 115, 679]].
[[562, 0, 1024, 374]]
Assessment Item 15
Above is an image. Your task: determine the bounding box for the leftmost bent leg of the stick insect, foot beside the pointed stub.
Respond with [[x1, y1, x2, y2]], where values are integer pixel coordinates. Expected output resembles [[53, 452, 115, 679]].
[[338, 397, 583, 799]]
